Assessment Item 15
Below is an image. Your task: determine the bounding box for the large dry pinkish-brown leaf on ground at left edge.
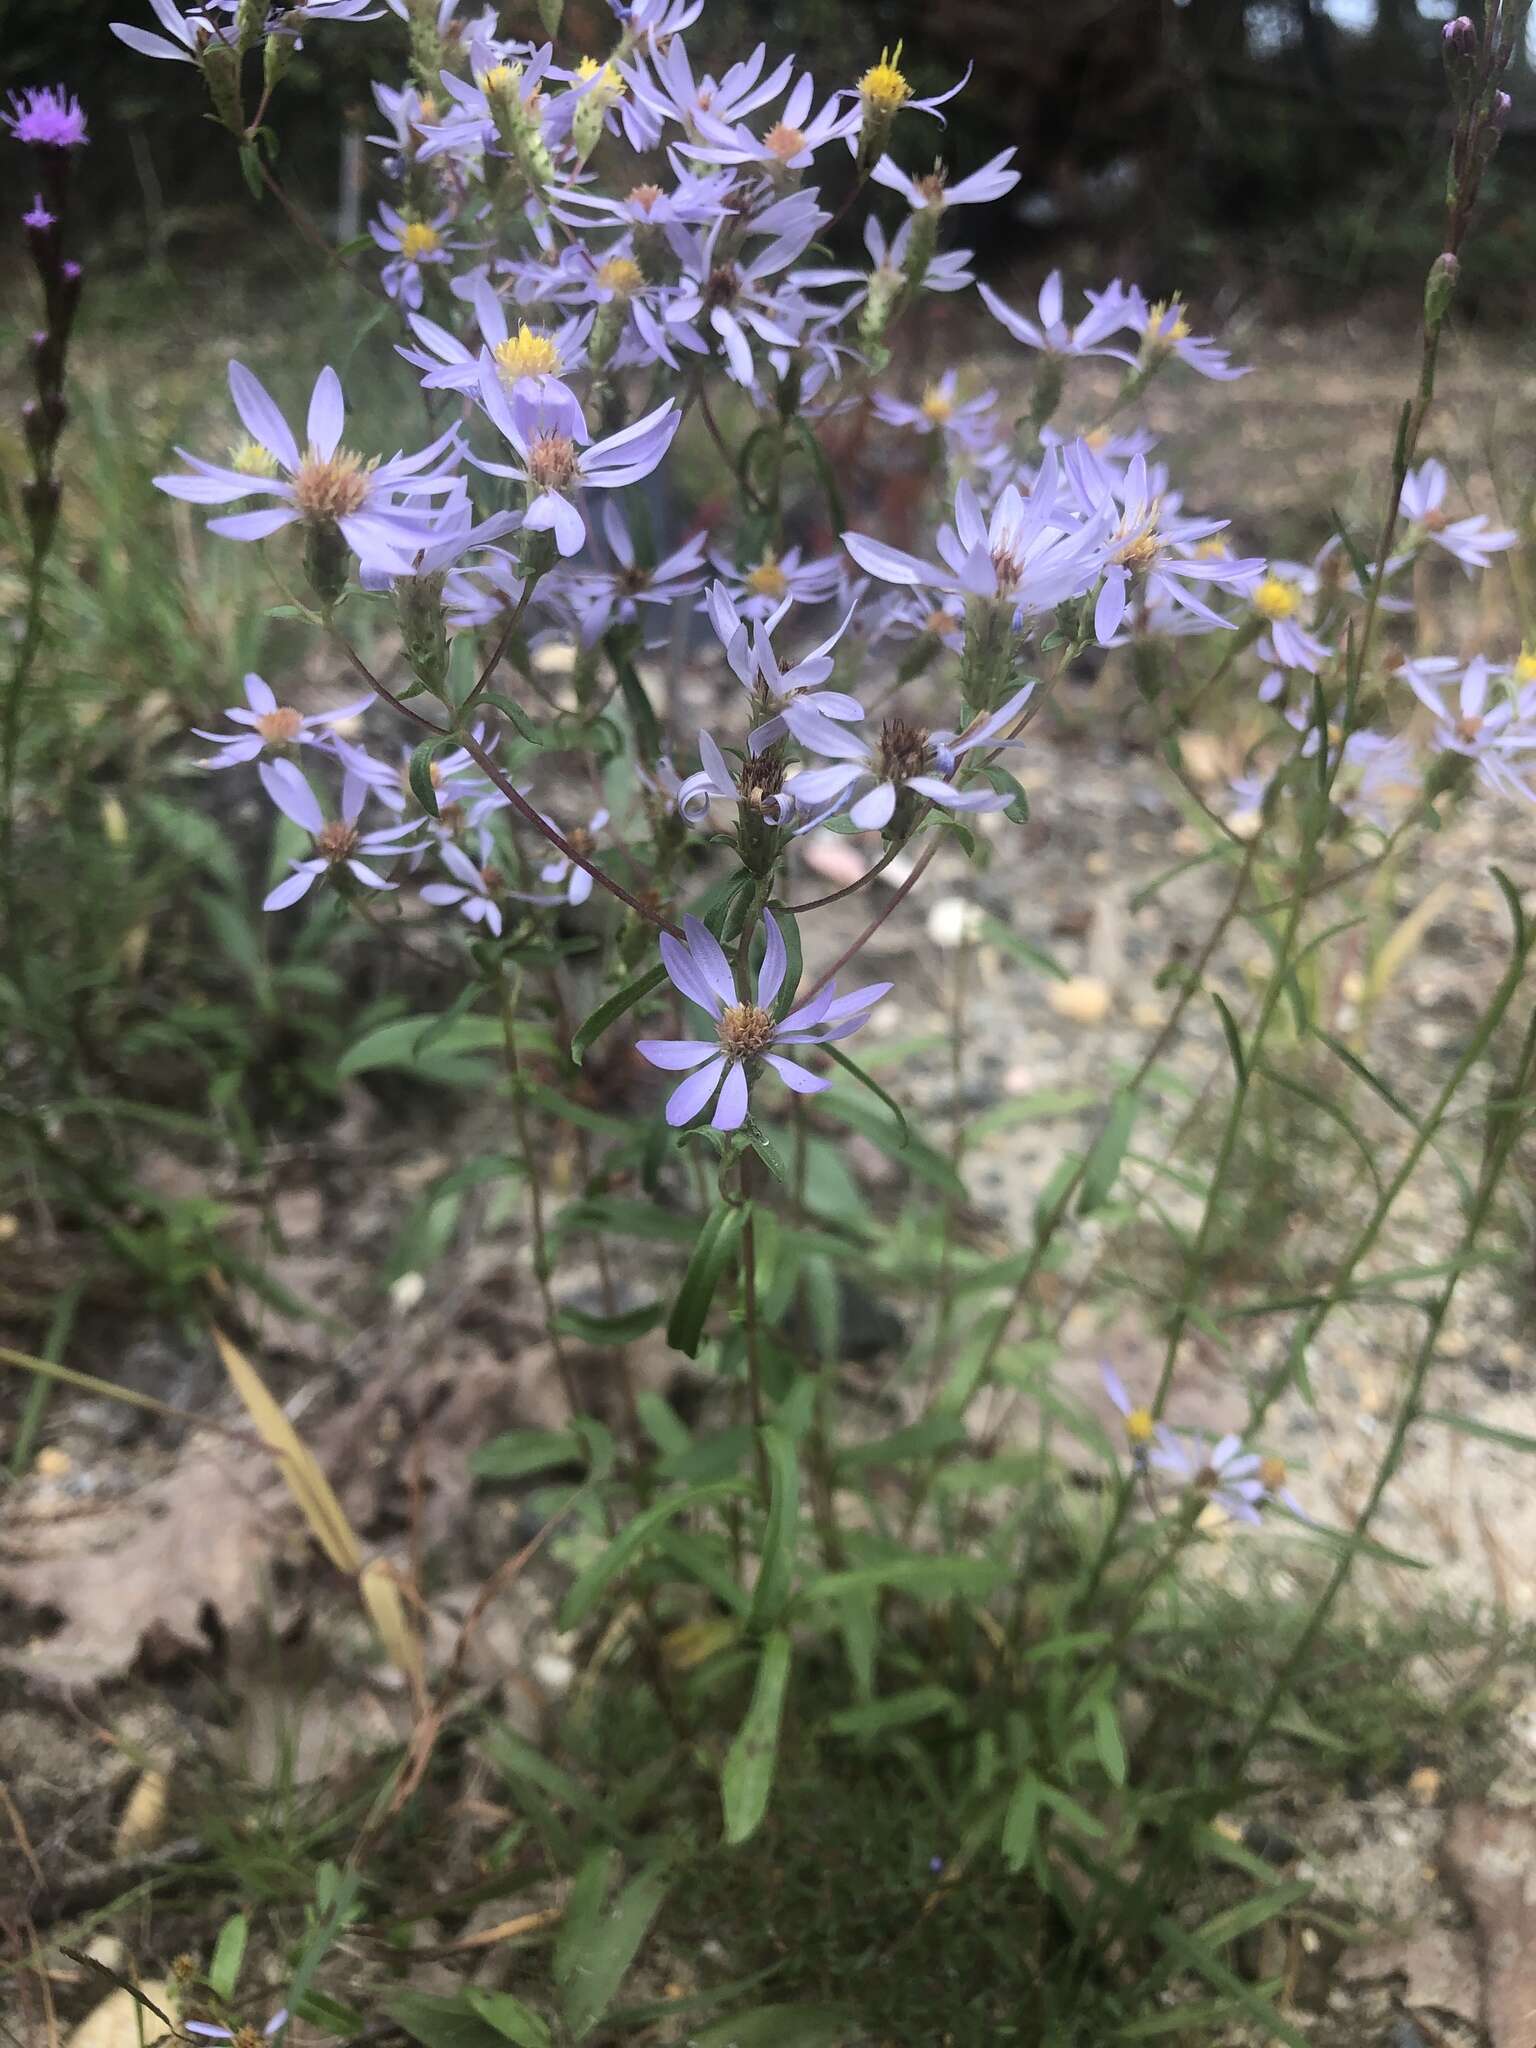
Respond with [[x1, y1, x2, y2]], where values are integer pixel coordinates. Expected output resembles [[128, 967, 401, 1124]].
[[0, 1450, 276, 1688]]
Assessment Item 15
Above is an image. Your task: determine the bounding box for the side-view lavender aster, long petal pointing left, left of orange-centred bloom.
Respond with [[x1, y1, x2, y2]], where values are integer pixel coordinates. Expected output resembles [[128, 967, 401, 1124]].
[[842, 466, 1112, 623]]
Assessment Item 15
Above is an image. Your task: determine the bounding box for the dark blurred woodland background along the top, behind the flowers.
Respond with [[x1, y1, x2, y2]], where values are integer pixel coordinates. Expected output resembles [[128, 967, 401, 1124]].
[[6, 0, 1536, 319]]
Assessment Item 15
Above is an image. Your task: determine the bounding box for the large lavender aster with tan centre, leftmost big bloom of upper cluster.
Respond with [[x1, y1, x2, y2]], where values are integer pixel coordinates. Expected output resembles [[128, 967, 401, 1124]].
[[154, 362, 463, 573]]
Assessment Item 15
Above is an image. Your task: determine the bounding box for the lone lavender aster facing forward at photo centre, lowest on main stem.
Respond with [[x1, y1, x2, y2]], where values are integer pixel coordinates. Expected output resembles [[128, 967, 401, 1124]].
[[635, 911, 893, 1130]]
